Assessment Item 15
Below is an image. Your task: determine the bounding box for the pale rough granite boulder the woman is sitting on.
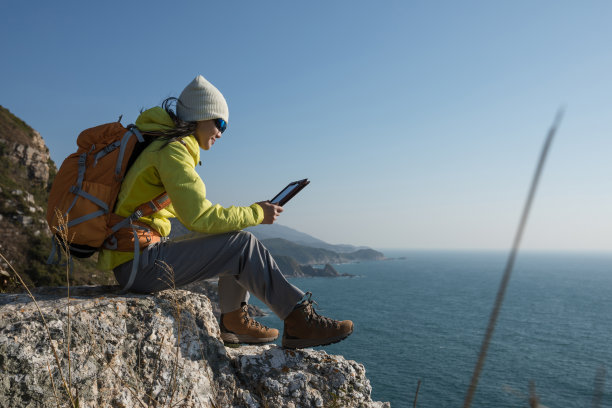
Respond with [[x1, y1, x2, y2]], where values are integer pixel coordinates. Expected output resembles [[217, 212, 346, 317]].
[[0, 287, 389, 408]]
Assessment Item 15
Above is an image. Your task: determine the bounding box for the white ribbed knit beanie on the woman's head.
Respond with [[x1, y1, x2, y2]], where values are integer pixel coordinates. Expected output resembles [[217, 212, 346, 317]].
[[176, 75, 229, 122]]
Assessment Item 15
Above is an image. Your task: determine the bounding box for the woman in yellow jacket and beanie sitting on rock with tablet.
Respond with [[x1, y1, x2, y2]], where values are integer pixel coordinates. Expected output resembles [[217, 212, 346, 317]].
[[98, 75, 353, 348]]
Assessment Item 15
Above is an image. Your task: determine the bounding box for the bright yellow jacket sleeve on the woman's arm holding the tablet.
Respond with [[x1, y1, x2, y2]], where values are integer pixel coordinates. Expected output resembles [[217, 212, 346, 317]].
[[156, 142, 263, 234]]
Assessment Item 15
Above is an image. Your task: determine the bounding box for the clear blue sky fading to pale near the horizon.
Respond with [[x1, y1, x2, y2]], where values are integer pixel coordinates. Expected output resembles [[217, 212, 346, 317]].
[[0, 0, 612, 250]]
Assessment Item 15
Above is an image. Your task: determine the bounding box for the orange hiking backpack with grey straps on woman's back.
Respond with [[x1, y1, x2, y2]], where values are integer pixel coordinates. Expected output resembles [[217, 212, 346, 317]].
[[47, 122, 170, 264]]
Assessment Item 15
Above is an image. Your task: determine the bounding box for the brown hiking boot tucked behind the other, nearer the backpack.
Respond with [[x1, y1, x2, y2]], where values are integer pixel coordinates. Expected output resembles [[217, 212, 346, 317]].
[[219, 302, 278, 344]]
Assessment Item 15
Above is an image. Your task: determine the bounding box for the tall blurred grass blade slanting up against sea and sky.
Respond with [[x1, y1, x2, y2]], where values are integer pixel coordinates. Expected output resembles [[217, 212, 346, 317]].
[[463, 109, 563, 408]]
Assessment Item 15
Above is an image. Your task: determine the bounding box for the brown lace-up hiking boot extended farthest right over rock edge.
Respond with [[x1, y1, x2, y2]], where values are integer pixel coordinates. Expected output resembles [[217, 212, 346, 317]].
[[283, 292, 353, 349]]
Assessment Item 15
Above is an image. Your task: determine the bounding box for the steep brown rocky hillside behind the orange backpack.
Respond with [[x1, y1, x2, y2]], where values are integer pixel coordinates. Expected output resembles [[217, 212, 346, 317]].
[[0, 106, 112, 291]]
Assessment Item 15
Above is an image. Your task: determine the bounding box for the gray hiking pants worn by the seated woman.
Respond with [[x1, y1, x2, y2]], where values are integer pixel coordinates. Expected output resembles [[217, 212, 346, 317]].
[[114, 231, 304, 320]]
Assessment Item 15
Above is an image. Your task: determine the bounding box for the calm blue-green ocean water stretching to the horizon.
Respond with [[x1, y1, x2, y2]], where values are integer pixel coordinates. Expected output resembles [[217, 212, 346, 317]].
[[251, 251, 612, 408]]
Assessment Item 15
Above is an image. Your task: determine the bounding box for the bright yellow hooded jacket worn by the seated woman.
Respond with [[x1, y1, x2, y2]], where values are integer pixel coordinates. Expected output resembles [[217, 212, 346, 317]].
[[98, 107, 263, 270]]
